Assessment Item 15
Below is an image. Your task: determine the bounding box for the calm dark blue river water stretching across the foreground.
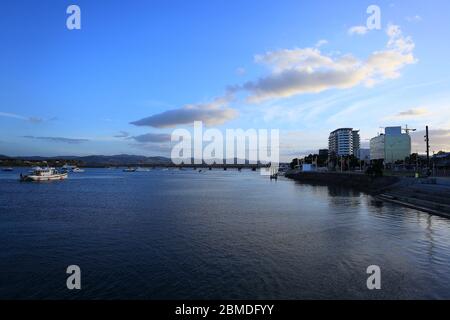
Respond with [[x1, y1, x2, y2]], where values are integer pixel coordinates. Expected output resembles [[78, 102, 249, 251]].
[[0, 169, 450, 299]]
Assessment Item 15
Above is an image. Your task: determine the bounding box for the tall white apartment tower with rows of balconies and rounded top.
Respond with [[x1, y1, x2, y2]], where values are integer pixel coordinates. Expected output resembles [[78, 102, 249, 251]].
[[328, 128, 360, 157]]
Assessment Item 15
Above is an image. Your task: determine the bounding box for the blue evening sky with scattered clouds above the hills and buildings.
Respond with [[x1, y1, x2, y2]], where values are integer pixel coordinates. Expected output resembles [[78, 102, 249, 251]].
[[0, 0, 450, 160]]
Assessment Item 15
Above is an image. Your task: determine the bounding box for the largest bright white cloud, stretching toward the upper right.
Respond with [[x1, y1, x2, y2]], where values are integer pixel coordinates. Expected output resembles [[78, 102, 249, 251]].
[[235, 25, 416, 103]]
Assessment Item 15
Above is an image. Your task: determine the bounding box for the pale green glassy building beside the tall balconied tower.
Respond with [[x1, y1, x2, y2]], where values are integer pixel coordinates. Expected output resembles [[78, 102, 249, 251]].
[[370, 127, 411, 163]]
